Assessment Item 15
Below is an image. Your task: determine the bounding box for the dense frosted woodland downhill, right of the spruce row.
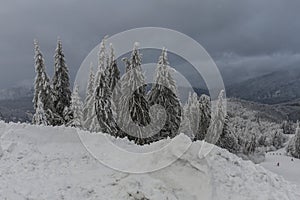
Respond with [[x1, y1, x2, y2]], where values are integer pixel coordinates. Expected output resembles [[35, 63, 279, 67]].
[[228, 109, 288, 163]]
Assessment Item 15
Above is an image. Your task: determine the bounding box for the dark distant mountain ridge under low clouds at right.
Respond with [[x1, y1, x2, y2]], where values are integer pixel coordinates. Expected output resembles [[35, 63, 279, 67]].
[[227, 69, 300, 104]]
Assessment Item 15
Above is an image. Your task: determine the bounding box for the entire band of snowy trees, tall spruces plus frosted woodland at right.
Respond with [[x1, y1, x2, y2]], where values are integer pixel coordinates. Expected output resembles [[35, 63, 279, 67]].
[[32, 36, 300, 160]]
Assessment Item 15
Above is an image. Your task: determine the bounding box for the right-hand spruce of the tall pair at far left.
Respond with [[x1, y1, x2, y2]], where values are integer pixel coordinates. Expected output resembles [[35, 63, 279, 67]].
[[52, 40, 72, 125]]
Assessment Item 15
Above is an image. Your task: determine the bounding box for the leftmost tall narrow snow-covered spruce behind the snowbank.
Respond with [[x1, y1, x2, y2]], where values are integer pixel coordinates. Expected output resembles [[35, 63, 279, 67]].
[[33, 40, 55, 125]]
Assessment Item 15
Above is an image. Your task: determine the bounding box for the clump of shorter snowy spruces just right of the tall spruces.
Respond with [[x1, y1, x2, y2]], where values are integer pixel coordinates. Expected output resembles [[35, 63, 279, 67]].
[[180, 91, 239, 153]]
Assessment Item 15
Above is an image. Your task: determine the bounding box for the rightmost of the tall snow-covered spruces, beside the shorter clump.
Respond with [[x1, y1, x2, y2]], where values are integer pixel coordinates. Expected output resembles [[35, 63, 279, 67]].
[[148, 48, 181, 140]]
